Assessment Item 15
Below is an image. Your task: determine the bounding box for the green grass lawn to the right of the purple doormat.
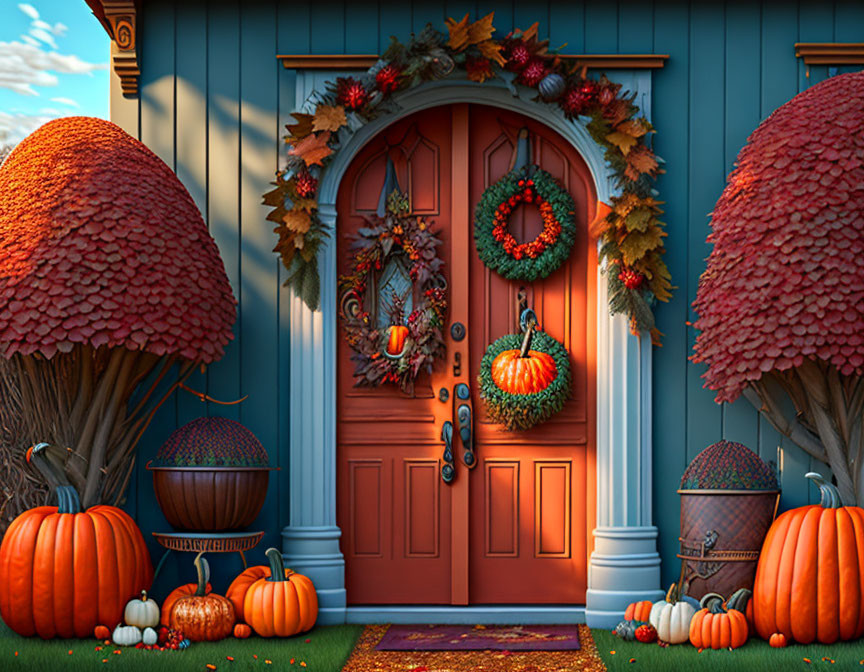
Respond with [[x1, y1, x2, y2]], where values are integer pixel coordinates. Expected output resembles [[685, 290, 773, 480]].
[[592, 630, 864, 672]]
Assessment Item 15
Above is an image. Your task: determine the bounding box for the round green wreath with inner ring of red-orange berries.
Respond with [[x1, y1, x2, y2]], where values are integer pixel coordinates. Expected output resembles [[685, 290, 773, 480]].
[[474, 165, 576, 282]]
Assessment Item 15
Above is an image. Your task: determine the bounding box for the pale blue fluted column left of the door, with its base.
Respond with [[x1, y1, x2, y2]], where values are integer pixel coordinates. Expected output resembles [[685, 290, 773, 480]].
[[282, 204, 345, 625]]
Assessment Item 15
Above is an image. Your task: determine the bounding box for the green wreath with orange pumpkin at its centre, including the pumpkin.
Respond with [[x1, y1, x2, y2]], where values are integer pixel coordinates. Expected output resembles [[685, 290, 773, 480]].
[[479, 319, 571, 431]]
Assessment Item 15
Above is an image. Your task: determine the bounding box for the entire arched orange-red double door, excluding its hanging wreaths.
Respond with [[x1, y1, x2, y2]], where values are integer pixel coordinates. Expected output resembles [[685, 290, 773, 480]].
[[337, 104, 596, 605]]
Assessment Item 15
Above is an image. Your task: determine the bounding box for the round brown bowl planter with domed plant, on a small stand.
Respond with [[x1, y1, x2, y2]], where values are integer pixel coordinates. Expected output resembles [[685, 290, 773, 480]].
[[147, 418, 275, 532]]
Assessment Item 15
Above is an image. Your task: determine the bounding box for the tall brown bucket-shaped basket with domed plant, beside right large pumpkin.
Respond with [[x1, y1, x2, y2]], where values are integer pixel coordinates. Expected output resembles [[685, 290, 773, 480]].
[[678, 441, 780, 599]]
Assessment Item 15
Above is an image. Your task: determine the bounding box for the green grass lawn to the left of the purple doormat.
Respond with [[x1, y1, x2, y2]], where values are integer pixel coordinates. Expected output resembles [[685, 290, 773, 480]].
[[0, 622, 363, 672]]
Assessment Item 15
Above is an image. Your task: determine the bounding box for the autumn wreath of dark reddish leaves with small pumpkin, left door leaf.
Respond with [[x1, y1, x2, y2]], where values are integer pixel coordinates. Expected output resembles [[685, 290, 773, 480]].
[[339, 190, 447, 394]]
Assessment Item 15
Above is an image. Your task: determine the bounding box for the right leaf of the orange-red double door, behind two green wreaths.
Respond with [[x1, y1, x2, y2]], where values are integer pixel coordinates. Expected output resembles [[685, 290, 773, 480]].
[[469, 106, 596, 603]]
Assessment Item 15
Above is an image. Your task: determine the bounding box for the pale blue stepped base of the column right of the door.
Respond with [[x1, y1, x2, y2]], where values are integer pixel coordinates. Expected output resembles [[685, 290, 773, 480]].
[[585, 526, 664, 629]]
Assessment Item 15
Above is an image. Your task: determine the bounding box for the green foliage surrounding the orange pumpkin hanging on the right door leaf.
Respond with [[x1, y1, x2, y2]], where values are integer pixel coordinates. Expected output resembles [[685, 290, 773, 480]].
[[479, 331, 570, 431]]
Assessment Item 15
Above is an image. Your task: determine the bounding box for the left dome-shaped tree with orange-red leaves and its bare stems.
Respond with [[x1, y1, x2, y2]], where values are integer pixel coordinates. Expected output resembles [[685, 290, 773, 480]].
[[0, 117, 236, 506]]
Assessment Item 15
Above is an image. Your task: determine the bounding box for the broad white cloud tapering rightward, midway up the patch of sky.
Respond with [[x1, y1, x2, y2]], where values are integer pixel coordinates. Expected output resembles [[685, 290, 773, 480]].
[[0, 41, 108, 96]]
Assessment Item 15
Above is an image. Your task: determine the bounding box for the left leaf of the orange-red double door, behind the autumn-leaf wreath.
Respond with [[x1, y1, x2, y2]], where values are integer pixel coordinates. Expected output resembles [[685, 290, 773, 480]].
[[336, 111, 451, 604]]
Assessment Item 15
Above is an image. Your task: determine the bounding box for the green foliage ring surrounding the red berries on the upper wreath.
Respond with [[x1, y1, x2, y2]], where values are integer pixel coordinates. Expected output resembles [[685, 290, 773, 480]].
[[474, 165, 576, 282]]
